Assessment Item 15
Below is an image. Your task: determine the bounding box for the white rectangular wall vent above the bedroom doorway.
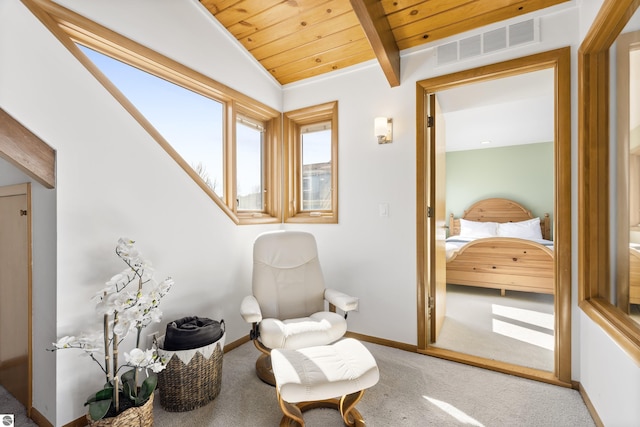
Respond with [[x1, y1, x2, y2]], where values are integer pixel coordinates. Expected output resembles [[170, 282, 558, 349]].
[[437, 19, 540, 65]]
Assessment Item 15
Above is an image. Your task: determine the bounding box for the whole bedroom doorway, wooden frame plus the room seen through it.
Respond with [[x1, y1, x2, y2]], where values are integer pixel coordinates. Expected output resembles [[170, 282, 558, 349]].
[[417, 48, 571, 384]]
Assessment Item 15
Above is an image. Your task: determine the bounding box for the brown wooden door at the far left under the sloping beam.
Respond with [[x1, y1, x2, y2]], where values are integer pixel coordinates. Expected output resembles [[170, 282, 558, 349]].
[[0, 184, 31, 409]]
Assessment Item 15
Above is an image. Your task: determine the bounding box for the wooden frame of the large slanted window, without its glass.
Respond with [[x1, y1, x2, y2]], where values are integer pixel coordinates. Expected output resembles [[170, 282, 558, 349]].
[[23, 0, 282, 225]]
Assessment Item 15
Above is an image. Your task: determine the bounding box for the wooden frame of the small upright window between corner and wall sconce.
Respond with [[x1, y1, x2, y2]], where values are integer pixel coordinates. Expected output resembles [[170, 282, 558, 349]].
[[283, 101, 338, 224]]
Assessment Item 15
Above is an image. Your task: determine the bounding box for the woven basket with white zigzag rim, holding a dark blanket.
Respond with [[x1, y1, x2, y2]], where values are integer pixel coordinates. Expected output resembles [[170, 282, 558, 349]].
[[158, 334, 226, 412]]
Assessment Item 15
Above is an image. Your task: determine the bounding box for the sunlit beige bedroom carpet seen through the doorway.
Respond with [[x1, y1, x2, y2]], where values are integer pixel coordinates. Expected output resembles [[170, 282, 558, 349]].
[[435, 285, 554, 372]]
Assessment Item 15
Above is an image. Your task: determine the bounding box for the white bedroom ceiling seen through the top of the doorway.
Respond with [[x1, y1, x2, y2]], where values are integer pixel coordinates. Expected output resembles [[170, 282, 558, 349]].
[[437, 68, 554, 151]]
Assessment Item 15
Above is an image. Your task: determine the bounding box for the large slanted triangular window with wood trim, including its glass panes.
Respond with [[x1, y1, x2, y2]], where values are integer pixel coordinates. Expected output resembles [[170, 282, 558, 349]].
[[33, 3, 282, 224]]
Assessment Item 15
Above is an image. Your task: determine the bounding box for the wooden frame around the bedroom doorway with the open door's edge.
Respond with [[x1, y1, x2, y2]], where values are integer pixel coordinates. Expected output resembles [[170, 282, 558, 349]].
[[417, 48, 571, 386]]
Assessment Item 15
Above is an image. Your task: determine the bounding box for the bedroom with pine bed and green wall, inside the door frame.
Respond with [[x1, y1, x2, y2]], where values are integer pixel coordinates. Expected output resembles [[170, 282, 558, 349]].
[[440, 123, 555, 372]]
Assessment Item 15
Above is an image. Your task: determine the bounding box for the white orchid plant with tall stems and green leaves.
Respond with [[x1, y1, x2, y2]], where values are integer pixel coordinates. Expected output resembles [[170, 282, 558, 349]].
[[51, 238, 173, 421]]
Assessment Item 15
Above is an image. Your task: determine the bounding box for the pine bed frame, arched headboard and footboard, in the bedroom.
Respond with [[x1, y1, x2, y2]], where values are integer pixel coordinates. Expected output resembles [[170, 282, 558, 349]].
[[447, 198, 555, 296]]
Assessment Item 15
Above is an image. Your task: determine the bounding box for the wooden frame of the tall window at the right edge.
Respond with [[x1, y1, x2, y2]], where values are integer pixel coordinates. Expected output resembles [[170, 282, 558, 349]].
[[578, 0, 640, 364]]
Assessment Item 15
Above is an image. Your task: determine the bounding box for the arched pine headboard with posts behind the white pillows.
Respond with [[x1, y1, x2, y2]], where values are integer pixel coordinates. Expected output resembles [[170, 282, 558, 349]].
[[449, 198, 551, 240]]
